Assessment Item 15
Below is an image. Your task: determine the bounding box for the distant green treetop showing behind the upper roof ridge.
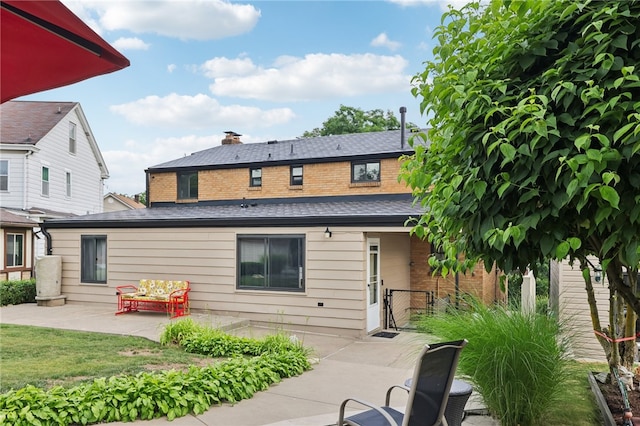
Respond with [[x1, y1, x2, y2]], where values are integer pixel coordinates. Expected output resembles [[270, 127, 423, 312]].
[[302, 105, 400, 138]]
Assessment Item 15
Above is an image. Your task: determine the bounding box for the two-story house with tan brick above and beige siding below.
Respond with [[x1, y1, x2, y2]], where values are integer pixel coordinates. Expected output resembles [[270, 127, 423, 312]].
[[44, 130, 502, 335]]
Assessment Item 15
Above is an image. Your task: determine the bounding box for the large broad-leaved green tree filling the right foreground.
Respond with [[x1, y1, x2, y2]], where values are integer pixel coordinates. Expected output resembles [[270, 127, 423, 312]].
[[402, 0, 640, 365]]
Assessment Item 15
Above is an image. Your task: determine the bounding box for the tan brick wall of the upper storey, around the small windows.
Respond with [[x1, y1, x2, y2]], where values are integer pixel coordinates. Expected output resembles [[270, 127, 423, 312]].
[[149, 158, 410, 202]]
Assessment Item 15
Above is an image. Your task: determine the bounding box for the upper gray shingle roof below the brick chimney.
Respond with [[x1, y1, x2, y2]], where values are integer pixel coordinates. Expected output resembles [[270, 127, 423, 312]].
[[147, 130, 421, 172]]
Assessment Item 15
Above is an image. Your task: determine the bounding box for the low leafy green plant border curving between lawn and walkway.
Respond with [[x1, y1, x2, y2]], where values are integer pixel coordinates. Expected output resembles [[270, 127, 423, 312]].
[[0, 318, 310, 425]]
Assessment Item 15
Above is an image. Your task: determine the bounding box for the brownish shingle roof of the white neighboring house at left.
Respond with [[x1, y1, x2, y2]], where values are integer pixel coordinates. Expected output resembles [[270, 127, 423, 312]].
[[0, 101, 78, 145]]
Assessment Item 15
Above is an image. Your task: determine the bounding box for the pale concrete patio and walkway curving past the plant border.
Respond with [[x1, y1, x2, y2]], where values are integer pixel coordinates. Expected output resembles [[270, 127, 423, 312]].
[[0, 303, 498, 426]]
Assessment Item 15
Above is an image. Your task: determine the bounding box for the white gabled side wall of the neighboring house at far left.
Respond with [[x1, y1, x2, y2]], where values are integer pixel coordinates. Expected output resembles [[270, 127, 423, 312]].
[[21, 109, 103, 215]]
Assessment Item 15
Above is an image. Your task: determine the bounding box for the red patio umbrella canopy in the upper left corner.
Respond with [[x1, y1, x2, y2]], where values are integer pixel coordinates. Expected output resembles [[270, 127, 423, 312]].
[[0, 0, 129, 102]]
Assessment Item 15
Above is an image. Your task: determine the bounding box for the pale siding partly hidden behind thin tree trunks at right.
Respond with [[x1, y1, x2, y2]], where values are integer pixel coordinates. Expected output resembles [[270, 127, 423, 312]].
[[551, 260, 609, 361]]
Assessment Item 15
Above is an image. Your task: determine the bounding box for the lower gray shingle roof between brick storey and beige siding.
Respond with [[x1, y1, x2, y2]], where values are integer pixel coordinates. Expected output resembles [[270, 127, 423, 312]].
[[43, 194, 423, 229]]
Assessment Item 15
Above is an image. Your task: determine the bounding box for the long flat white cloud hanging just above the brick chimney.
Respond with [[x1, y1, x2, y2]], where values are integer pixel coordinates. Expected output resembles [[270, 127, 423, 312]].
[[110, 93, 295, 129]]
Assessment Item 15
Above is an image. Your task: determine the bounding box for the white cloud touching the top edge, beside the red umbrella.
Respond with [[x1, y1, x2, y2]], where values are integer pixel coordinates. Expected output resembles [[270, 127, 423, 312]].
[[93, 0, 260, 40]]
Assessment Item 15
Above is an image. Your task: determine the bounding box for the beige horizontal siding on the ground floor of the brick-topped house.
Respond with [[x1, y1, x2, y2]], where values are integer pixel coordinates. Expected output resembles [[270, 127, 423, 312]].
[[49, 226, 409, 335]]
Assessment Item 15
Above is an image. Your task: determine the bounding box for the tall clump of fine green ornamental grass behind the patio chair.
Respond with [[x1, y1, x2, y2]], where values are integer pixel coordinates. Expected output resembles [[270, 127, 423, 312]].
[[419, 301, 569, 426]]
